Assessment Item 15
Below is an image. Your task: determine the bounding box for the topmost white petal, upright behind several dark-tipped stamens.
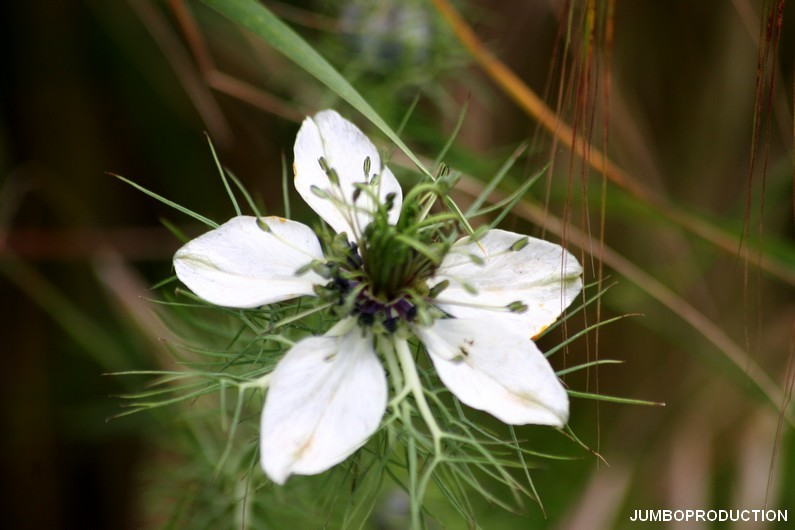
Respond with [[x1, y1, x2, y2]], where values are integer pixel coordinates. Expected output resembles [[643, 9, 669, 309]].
[[294, 110, 403, 240]]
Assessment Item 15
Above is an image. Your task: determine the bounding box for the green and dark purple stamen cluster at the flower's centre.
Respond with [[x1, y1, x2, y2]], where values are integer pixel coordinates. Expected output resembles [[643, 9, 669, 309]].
[[311, 158, 455, 332]]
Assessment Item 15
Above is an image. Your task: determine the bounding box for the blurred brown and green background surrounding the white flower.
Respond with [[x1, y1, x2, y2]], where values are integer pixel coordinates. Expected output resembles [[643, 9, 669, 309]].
[[0, 0, 795, 529]]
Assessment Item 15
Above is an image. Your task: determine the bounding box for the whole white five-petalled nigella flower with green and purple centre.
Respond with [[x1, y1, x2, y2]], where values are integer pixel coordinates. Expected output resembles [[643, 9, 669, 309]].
[[174, 110, 582, 484]]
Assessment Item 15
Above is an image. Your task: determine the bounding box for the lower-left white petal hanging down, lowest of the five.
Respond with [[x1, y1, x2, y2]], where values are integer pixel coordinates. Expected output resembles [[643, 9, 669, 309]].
[[260, 325, 387, 484]]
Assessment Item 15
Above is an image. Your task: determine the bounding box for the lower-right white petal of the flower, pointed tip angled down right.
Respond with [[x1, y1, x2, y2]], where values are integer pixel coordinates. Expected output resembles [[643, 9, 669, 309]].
[[416, 318, 569, 427]]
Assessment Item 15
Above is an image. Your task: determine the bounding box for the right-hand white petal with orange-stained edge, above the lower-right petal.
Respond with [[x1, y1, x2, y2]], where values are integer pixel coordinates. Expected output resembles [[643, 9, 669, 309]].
[[436, 229, 582, 337]]
